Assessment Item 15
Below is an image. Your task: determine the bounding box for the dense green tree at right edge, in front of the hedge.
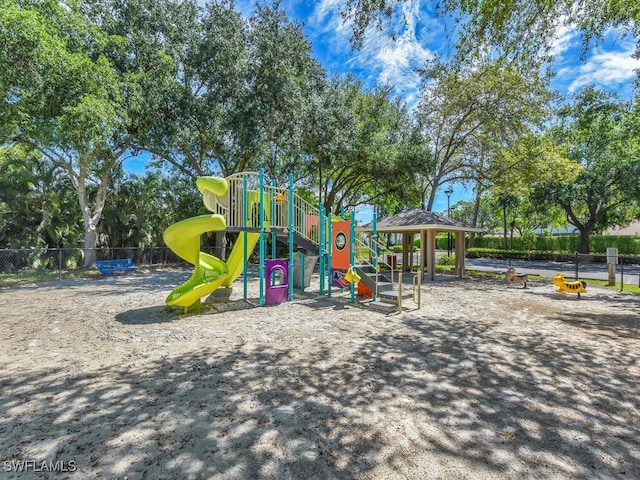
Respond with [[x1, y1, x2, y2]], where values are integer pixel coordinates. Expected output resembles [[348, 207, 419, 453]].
[[535, 87, 640, 253]]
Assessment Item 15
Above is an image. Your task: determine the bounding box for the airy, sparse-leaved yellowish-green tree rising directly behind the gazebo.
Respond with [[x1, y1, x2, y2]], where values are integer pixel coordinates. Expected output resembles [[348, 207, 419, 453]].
[[413, 56, 551, 210]]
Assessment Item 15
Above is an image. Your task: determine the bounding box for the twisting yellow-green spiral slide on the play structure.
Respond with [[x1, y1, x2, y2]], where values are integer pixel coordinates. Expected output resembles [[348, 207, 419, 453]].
[[163, 177, 260, 307]]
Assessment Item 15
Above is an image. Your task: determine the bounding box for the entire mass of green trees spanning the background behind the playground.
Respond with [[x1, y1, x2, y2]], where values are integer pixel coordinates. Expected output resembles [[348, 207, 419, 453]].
[[0, 0, 640, 255]]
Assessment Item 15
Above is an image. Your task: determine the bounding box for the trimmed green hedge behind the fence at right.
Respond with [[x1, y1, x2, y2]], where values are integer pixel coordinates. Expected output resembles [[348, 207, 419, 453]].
[[470, 235, 640, 255]]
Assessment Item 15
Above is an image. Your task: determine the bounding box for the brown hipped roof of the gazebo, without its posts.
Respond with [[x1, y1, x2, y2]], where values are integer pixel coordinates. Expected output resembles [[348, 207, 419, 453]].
[[357, 208, 482, 232]]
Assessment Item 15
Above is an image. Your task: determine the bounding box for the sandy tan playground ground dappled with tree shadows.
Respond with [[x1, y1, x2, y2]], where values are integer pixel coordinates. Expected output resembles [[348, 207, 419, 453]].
[[0, 271, 640, 479]]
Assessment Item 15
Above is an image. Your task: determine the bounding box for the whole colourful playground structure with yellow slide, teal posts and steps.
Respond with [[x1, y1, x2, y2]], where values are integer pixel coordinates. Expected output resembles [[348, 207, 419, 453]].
[[163, 171, 424, 311]]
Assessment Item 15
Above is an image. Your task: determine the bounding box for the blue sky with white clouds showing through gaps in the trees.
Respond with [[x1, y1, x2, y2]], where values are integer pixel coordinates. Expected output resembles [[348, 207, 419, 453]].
[[126, 0, 640, 221]]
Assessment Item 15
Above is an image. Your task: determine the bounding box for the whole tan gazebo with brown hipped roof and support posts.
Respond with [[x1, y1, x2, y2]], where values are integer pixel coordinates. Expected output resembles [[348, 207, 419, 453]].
[[356, 208, 482, 282]]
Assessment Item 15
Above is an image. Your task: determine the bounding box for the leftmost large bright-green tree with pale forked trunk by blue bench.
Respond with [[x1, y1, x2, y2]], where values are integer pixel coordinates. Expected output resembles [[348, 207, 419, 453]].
[[0, 0, 178, 266]]
